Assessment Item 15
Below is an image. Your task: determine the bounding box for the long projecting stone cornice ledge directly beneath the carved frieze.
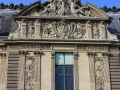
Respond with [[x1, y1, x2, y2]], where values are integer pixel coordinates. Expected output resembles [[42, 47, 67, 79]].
[[4, 39, 120, 45]]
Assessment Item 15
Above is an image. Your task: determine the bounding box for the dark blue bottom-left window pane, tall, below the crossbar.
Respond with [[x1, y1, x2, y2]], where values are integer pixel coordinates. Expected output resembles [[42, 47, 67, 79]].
[[55, 76, 64, 90]]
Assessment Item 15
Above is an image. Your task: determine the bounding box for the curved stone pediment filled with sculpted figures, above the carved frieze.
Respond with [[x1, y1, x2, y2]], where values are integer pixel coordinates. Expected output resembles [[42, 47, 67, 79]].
[[18, 0, 108, 19]]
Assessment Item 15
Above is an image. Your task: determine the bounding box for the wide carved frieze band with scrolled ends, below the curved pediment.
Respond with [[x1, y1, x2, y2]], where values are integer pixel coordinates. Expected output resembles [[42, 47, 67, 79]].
[[8, 19, 118, 40]]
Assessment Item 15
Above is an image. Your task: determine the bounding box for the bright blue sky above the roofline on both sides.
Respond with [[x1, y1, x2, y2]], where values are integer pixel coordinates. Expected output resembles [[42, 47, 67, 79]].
[[0, 0, 120, 8]]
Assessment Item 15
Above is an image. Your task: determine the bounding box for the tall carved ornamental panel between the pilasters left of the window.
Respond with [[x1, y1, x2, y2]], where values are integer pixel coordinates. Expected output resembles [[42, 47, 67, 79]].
[[25, 53, 35, 90]]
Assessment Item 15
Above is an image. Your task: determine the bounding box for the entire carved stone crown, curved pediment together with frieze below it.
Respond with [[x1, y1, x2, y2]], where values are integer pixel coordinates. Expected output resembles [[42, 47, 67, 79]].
[[8, 0, 118, 40]]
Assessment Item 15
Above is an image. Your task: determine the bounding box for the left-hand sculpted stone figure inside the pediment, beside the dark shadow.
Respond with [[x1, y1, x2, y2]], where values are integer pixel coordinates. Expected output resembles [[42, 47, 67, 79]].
[[40, 0, 57, 15]]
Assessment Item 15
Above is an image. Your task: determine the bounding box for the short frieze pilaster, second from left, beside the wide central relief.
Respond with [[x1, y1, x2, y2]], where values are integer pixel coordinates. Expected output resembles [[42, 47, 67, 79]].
[[35, 19, 42, 39]]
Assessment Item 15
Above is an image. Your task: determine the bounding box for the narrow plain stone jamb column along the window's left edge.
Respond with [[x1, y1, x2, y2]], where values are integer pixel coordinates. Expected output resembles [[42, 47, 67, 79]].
[[51, 52, 55, 90]]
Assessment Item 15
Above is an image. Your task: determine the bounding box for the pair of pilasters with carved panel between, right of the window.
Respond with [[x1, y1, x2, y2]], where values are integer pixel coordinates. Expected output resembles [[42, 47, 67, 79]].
[[88, 52, 110, 90]]
